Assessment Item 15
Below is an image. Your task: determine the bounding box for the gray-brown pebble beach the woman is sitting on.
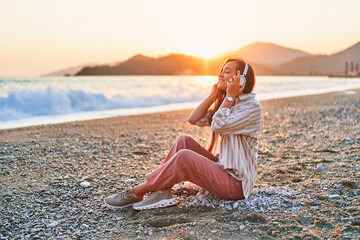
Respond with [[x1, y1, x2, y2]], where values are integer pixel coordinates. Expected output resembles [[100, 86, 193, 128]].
[[0, 89, 360, 239]]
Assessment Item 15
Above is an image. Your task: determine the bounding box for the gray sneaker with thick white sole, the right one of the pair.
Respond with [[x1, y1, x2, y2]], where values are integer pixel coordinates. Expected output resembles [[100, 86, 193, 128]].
[[133, 189, 176, 210]]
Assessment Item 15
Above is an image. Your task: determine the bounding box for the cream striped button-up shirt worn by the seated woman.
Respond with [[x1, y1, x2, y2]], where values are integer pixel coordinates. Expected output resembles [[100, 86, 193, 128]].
[[198, 93, 262, 198]]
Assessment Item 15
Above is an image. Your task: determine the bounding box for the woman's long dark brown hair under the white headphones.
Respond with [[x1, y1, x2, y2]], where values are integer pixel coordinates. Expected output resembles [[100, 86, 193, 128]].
[[207, 58, 256, 152]]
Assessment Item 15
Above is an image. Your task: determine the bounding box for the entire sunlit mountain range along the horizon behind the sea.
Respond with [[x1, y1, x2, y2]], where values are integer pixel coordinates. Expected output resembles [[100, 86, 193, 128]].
[[47, 42, 360, 76]]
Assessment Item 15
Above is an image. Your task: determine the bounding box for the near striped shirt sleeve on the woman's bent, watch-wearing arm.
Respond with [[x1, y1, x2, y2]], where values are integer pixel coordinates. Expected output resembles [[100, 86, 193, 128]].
[[211, 108, 251, 134]]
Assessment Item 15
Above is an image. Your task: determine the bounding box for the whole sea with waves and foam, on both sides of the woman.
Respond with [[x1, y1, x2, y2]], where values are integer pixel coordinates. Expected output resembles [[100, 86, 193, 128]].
[[0, 76, 360, 129]]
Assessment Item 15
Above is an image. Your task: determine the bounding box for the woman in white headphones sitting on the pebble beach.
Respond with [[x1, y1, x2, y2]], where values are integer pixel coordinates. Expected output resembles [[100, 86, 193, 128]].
[[104, 59, 261, 210]]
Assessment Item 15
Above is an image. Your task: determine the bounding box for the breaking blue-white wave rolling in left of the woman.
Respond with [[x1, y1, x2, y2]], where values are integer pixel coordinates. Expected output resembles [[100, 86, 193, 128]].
[[0, 87, 204, 121]]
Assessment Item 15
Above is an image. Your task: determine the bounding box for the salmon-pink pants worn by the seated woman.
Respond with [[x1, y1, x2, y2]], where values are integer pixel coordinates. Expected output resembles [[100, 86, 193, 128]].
[[146, 135, 244, 199]]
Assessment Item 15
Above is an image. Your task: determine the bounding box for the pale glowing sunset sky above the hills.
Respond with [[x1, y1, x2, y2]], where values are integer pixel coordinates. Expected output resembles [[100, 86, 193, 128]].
[[0, 0, 360, 77]]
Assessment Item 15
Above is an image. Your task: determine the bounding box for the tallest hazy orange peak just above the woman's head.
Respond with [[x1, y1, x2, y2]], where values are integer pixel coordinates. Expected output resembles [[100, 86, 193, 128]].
[[223, 42, 312, 65]]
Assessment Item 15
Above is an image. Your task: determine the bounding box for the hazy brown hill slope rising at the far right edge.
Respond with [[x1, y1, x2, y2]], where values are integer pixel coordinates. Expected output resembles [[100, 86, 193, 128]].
[[273, 42, 360, 75]]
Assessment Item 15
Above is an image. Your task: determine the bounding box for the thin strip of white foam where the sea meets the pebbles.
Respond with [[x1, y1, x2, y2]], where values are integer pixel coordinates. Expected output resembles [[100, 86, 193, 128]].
[[0, 88, 360, 131]]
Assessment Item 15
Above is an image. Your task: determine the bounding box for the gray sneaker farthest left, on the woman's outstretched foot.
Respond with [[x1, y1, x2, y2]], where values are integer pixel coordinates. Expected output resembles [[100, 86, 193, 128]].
[[104, 188, 141, 208]]
